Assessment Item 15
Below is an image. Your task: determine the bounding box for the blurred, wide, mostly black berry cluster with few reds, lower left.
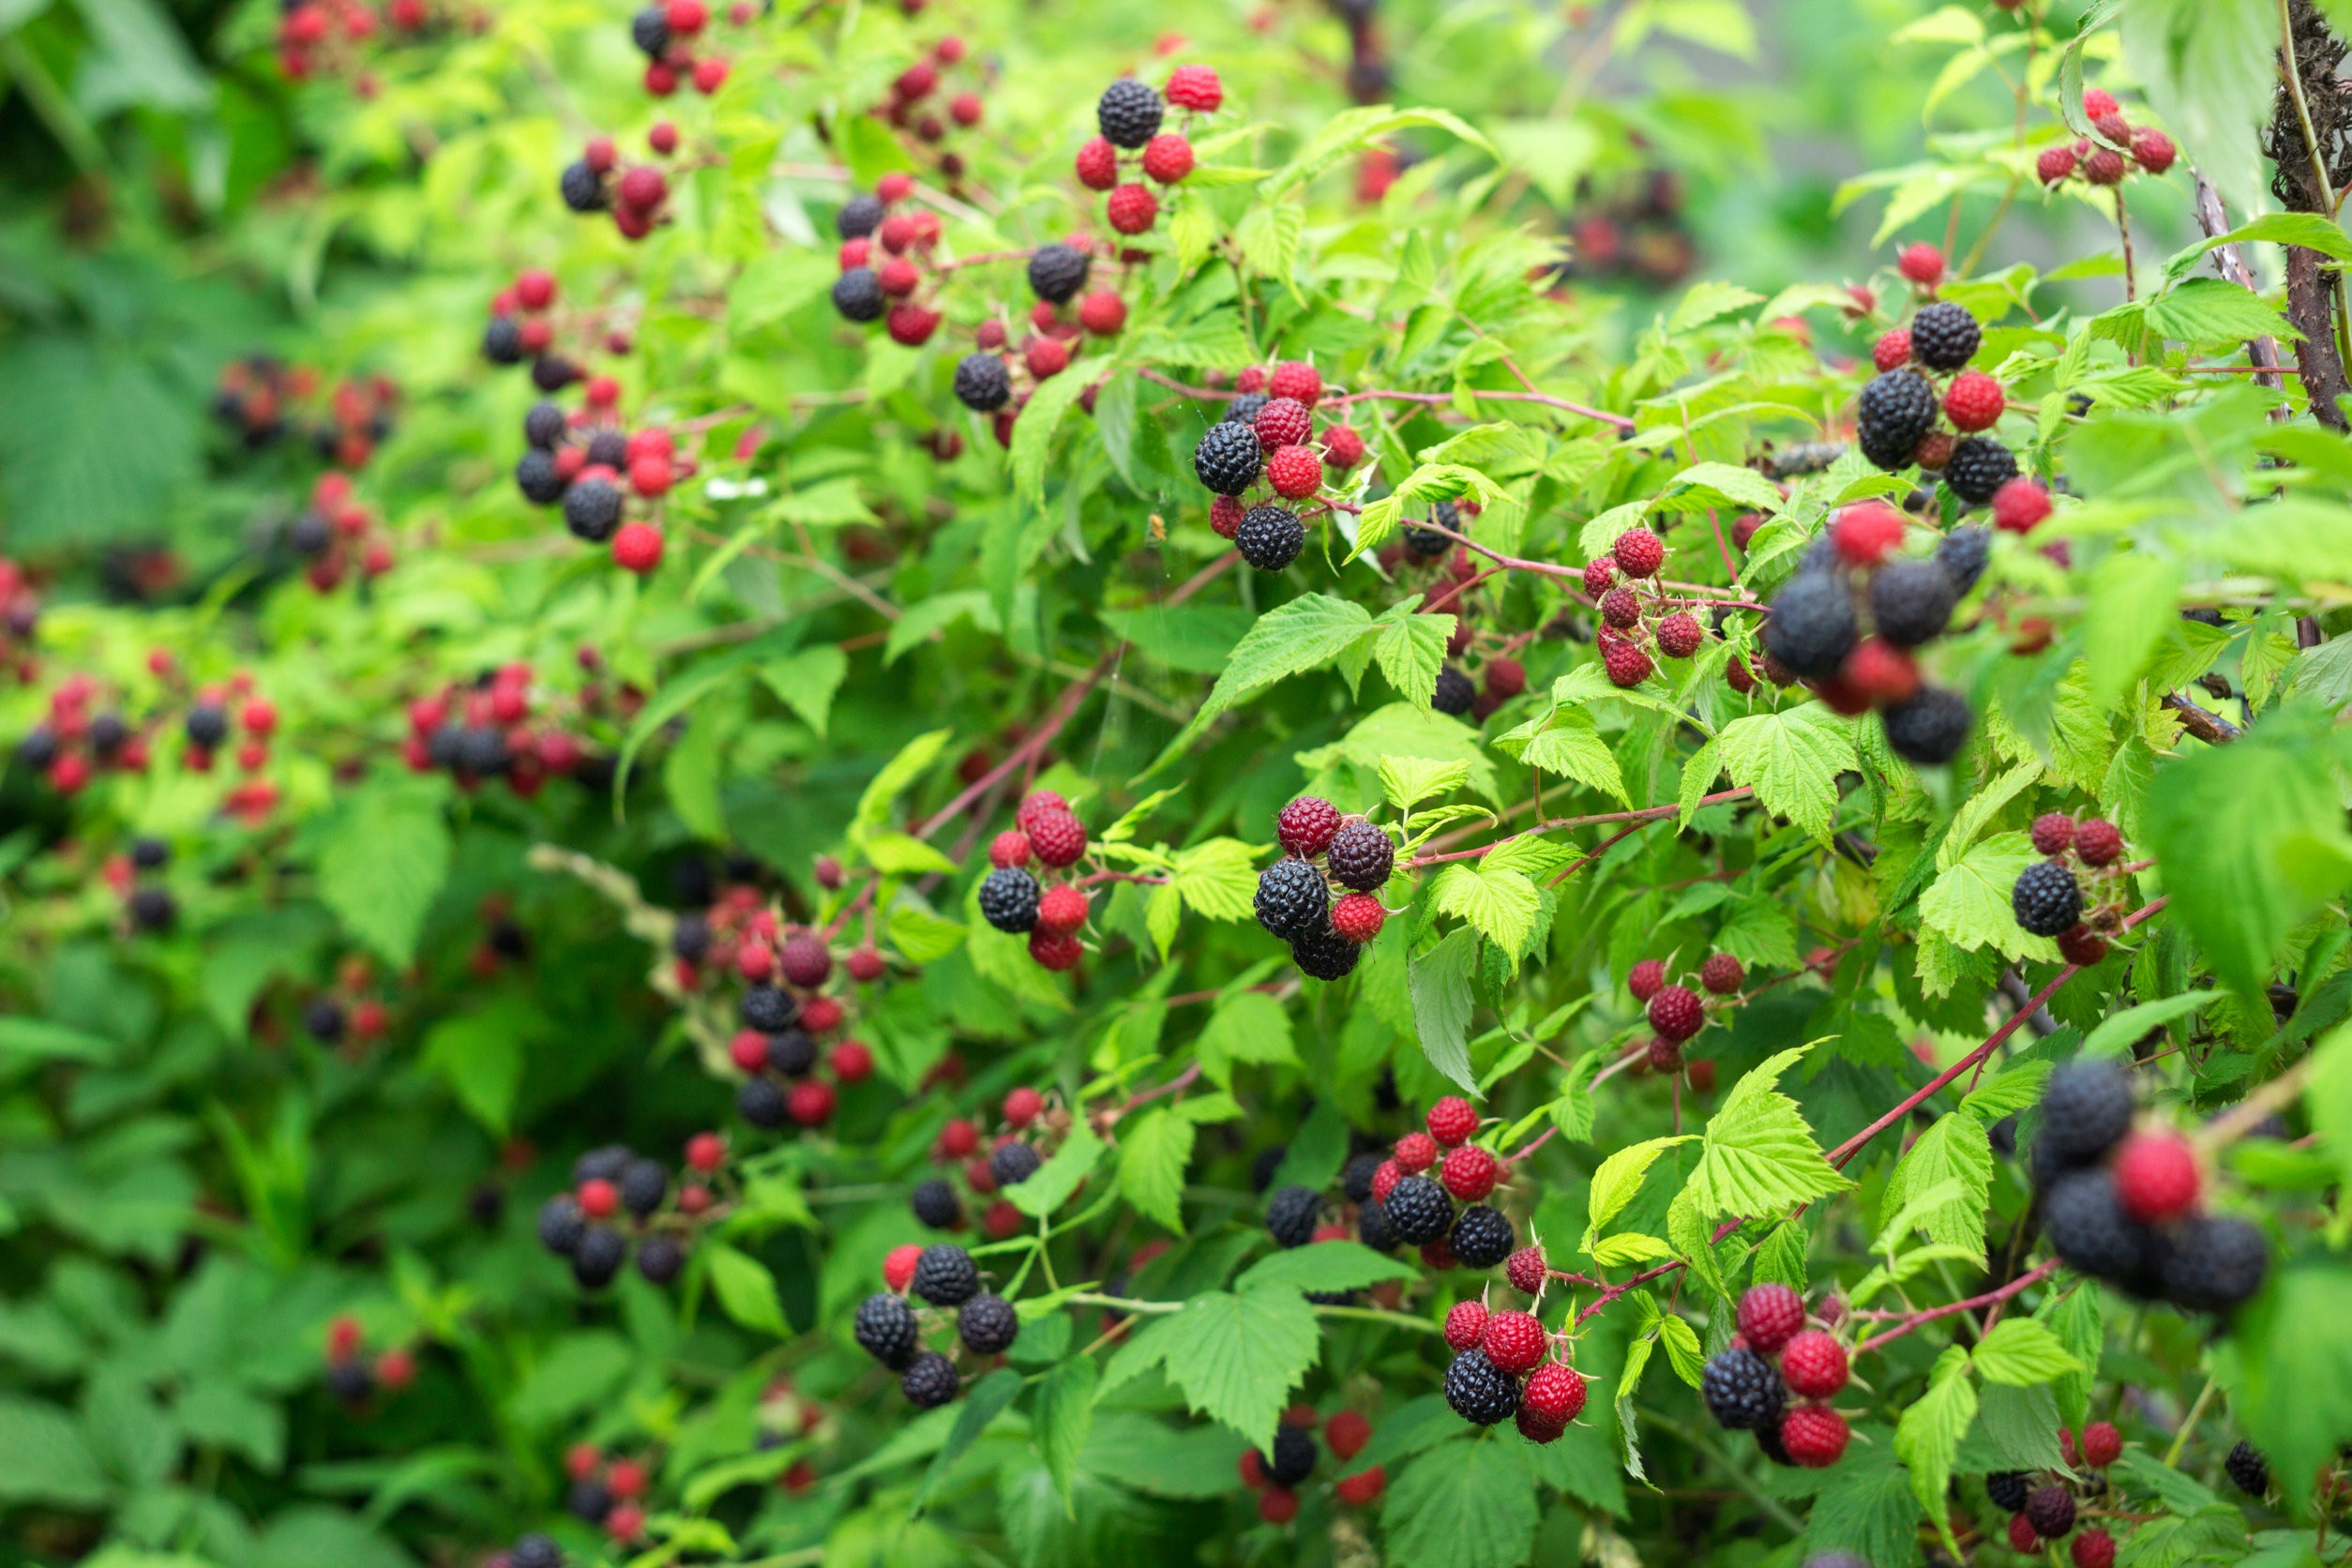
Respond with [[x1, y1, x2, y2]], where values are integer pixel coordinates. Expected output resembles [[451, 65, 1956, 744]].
[[538, 1133, 727, 1290]]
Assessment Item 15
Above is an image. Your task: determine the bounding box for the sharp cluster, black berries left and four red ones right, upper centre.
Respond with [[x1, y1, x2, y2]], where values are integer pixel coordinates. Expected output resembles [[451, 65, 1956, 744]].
[[1193, 360, 1364, 571]]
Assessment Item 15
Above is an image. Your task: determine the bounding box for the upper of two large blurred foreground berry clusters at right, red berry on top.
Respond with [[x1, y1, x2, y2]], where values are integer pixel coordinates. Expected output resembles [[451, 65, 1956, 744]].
[[1764, 503, 1985, 764]]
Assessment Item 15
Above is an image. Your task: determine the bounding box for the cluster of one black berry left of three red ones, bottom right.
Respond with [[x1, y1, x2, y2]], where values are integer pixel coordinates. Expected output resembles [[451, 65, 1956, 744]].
[[1698, 1284, 1848, 1470]]
